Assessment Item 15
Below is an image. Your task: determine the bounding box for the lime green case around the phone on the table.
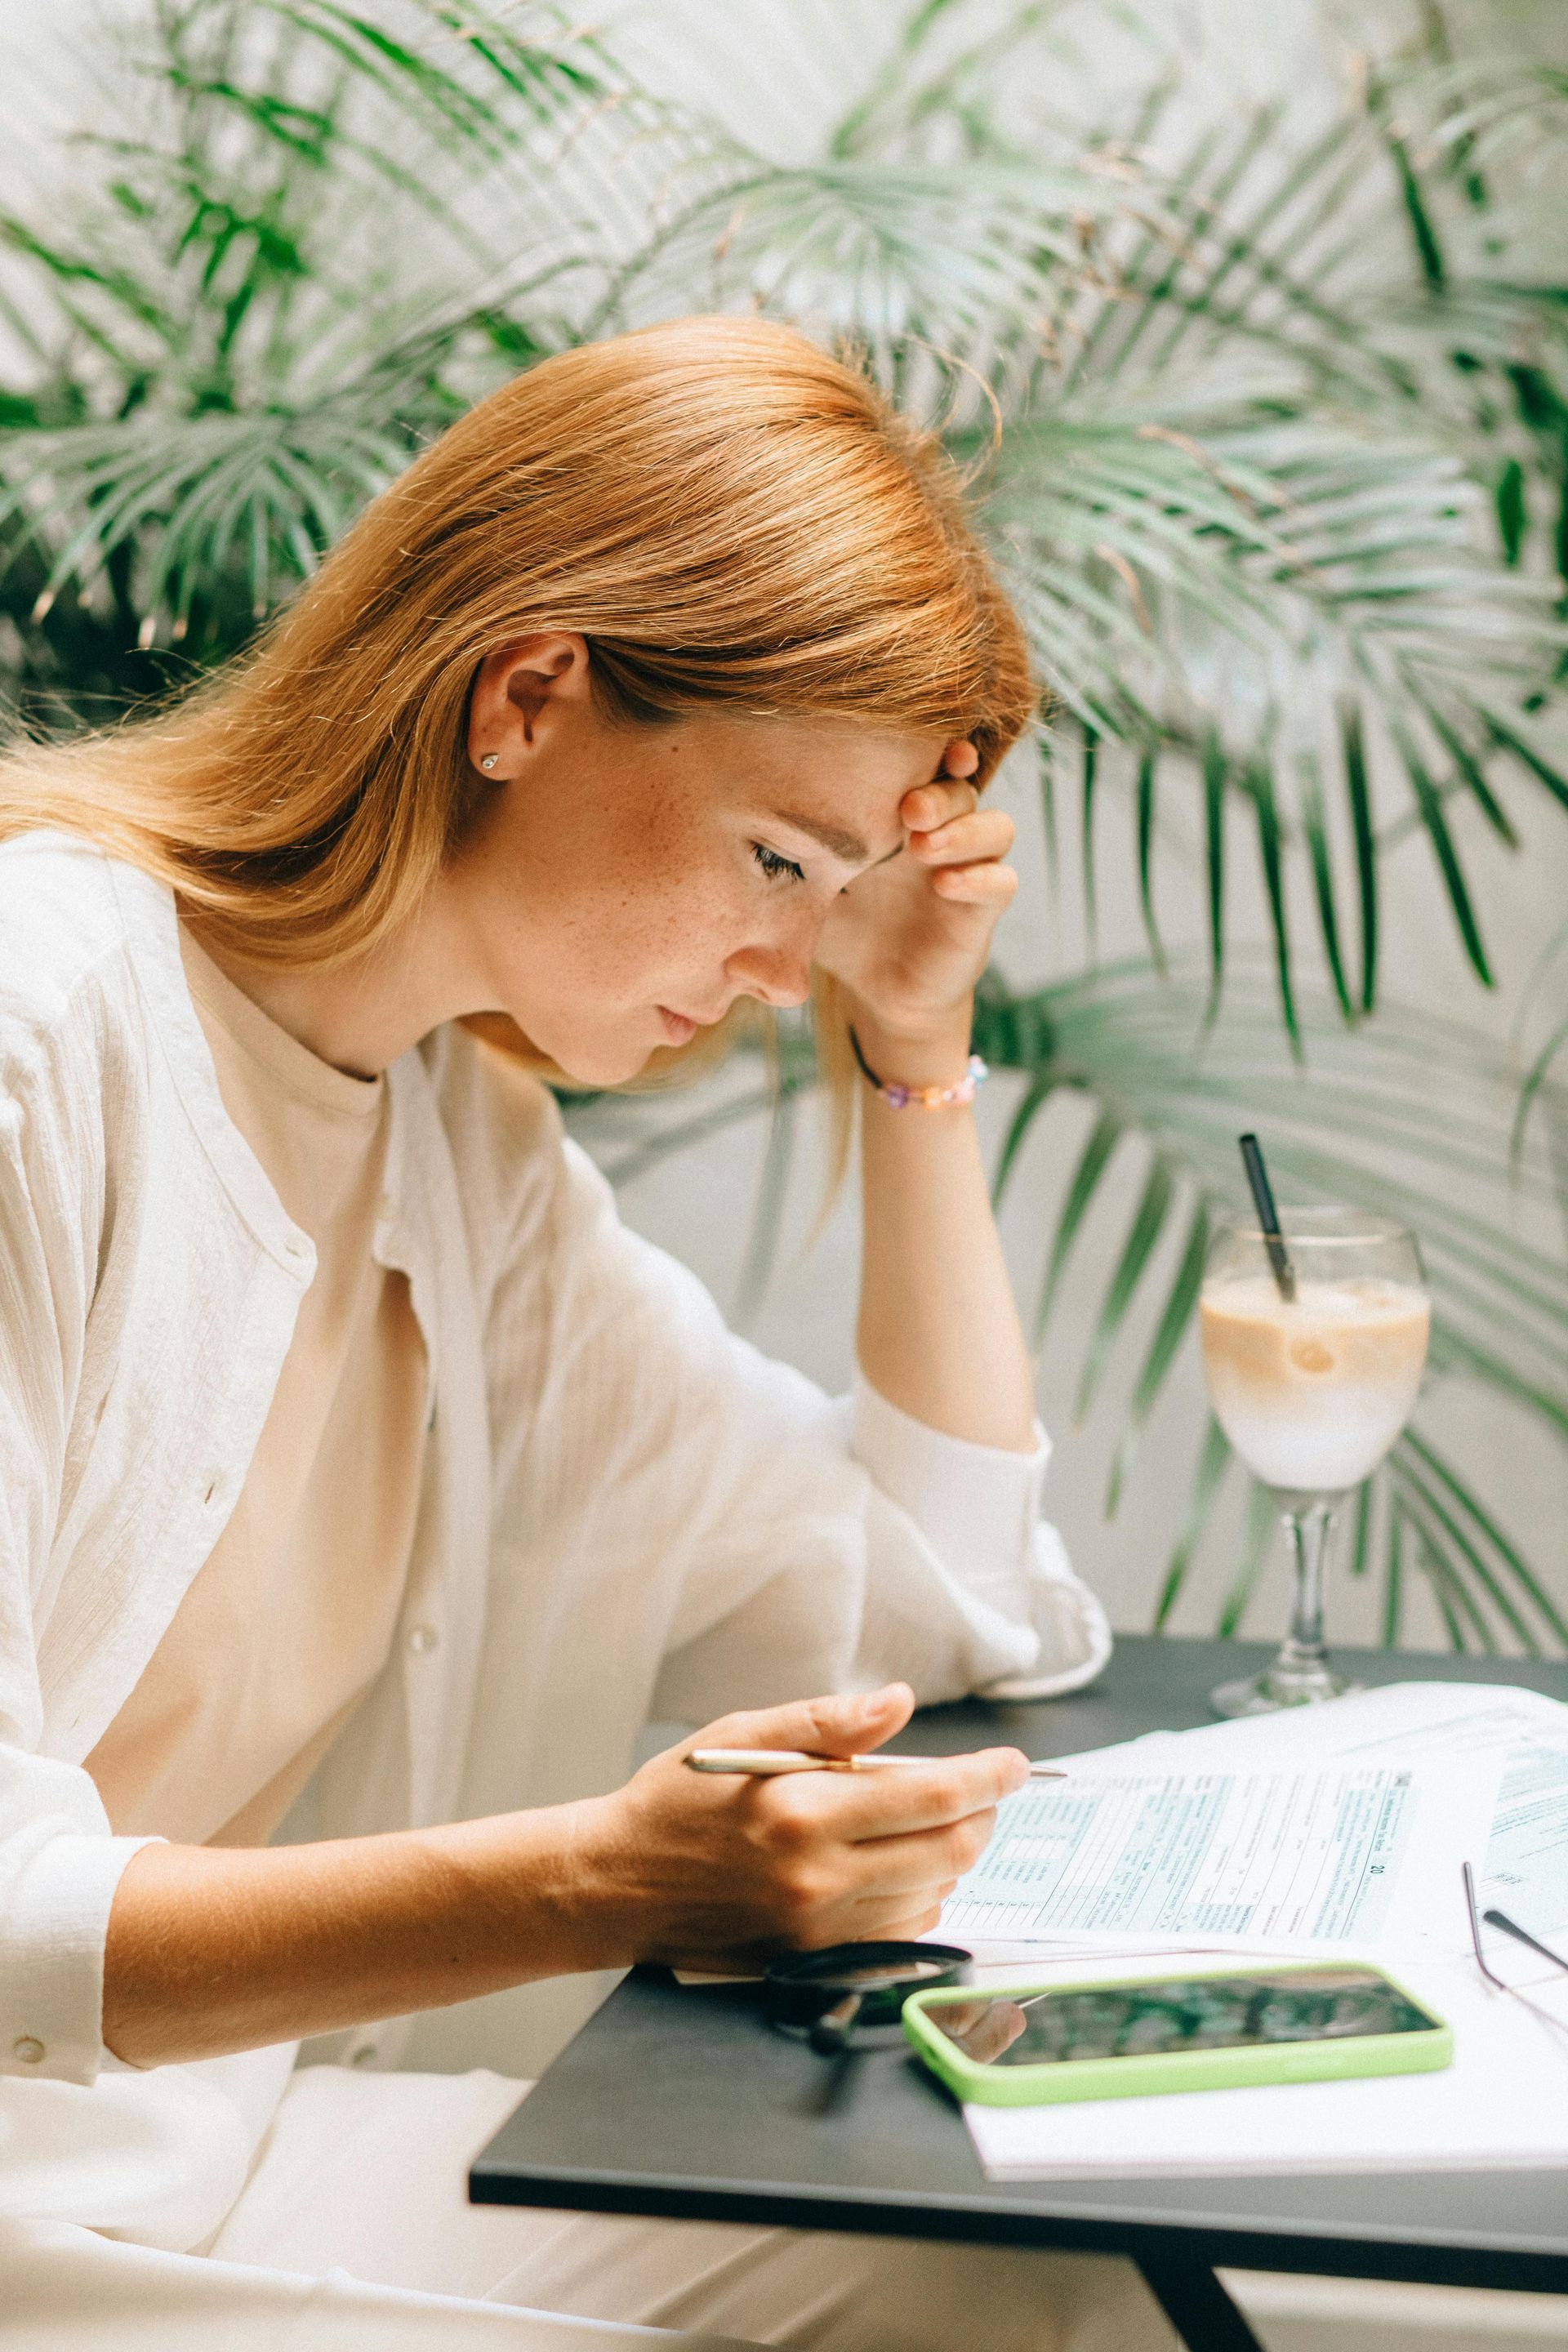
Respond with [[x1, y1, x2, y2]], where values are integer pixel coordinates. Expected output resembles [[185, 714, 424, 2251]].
[[902, 1962, 1453, 2107]]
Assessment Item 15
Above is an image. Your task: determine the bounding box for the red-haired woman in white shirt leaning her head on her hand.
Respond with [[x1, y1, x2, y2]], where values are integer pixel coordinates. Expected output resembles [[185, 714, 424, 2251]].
[[0, 320, 1169, 2352]]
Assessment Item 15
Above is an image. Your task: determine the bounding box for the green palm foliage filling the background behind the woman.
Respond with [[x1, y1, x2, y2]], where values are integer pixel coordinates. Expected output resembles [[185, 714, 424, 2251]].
[[0, 0, 1568, 1649]]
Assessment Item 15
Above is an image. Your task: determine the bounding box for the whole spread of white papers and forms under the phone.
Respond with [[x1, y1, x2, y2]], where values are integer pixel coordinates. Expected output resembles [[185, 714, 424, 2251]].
[[940, 1682, 1568, 2178]]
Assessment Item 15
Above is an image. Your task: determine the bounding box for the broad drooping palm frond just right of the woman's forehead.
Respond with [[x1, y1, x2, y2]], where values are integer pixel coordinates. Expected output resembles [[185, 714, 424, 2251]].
[[987, 385, 1566, 1030]]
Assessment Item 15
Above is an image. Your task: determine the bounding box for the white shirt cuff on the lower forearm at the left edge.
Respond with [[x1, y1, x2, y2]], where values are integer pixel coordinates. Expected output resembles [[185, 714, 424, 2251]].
[[0, 1834, 163, 2084]]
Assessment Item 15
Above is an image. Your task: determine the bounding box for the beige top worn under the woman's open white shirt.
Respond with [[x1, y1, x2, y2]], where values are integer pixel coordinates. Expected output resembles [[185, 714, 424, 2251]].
[[87, 927, 425, 1846]]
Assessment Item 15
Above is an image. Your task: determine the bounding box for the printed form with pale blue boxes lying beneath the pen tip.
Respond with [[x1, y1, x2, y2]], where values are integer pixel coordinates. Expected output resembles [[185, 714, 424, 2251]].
[[942, 1764, 1413, 1945]]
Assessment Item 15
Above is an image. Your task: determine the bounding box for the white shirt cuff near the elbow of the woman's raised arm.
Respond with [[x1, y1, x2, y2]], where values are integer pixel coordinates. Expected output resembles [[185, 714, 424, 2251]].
[[849, 1374, 1051, 1616]]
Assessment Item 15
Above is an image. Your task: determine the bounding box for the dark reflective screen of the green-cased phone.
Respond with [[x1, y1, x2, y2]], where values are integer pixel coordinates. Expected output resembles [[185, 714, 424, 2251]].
[[926, 1967, 1439, 2065]]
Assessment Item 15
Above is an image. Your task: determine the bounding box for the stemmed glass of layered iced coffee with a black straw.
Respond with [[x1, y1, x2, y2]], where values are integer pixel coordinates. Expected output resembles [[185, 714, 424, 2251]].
[[1199, 1209, 1432, 1715]]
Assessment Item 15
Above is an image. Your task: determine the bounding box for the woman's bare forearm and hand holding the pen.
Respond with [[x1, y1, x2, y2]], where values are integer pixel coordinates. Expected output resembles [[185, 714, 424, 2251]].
[[104, 1682, 1027, 2068]]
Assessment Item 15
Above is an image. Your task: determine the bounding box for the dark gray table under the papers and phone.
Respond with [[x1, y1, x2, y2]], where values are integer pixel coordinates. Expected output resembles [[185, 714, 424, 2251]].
[[470, 1637, 1568, 2352]]
